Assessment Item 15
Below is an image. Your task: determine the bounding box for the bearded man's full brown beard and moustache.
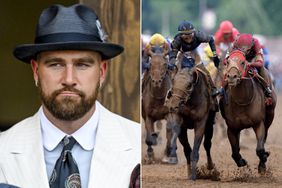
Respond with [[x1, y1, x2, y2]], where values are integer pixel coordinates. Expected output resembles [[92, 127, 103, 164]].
[[38, 80, 99, 121]]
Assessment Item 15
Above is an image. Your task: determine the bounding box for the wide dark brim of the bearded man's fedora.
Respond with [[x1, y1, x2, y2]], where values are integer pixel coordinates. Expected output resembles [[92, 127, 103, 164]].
[[13, 41, 124, 63]]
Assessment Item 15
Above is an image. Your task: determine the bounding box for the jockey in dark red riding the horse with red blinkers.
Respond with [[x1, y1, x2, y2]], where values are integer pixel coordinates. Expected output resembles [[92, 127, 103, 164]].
[[233, 34, 272, 98]]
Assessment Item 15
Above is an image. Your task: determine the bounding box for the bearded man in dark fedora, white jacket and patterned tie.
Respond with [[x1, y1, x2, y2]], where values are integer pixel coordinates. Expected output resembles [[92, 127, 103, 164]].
[[0, 4, 141, 188]]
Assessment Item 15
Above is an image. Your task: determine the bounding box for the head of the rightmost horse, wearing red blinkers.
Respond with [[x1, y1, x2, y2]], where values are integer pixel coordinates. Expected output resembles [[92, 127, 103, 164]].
[[225, 50, 249, 86]]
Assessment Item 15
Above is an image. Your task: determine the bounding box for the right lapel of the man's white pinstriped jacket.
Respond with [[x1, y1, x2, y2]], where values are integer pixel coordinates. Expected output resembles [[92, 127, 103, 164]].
[[88, 104, 136, 188]]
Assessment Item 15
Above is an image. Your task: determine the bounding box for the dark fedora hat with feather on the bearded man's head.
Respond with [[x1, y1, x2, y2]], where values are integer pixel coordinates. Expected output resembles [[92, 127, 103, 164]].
[[13, 4, 123, 63]]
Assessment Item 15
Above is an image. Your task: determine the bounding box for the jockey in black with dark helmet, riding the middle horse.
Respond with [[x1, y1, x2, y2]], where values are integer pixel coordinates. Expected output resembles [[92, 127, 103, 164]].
[[169, 21, 219, 110]]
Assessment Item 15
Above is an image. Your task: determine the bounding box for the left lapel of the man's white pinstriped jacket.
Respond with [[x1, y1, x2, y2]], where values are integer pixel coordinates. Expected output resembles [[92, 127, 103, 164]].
[[3, 113, 49, 188]]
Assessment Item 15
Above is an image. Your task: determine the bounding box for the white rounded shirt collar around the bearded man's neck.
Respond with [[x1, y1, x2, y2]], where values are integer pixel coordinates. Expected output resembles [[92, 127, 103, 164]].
[[39, 103, 99, 151]]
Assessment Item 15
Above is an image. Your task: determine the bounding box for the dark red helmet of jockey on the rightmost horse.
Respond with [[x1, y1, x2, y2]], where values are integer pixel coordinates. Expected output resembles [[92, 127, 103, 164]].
[[234, 34, 255, 53]]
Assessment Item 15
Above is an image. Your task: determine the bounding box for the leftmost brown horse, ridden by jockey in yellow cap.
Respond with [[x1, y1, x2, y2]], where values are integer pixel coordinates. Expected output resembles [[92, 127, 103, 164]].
[[142, 47, 171, 162]]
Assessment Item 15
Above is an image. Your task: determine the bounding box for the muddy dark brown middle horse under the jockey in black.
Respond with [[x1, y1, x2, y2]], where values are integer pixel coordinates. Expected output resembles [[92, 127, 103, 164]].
[[165, 67, 216, 180]]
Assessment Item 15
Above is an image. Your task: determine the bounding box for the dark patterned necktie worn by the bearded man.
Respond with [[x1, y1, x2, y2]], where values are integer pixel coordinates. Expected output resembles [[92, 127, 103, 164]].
[[49, 136, 81, 188]]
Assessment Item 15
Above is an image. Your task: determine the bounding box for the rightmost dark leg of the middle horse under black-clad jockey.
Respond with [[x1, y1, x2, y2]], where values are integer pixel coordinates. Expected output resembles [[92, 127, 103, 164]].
[[204, 111, 215, 170]]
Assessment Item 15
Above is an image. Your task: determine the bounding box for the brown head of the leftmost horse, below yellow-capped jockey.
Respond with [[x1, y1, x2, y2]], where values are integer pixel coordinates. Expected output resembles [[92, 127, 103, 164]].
[[149, 47, 168, 88]]
